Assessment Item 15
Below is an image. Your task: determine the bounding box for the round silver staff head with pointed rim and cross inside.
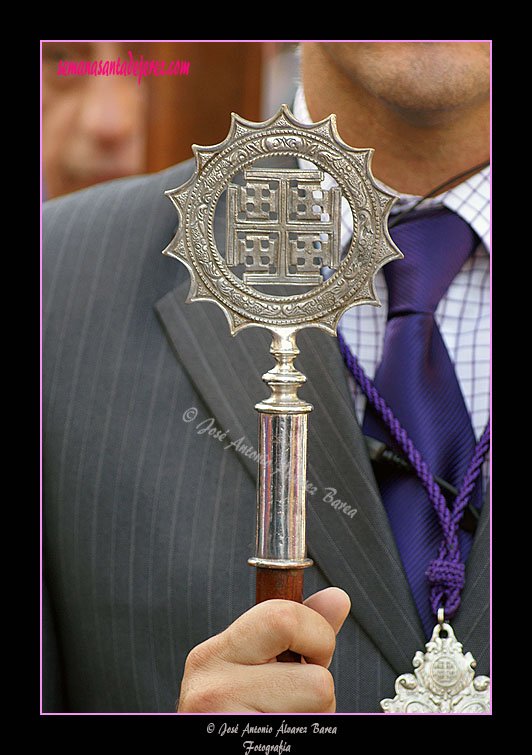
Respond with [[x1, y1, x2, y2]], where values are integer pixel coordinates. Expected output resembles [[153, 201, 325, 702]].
[[163, 105, 403, 336]]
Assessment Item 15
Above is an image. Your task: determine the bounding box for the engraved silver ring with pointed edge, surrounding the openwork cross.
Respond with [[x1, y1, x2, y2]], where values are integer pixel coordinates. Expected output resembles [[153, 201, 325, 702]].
[[163, 105, 402, 335]]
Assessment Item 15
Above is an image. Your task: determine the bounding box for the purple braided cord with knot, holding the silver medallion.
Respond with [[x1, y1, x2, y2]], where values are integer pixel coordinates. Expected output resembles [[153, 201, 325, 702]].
[[337, 331, 490, 619]]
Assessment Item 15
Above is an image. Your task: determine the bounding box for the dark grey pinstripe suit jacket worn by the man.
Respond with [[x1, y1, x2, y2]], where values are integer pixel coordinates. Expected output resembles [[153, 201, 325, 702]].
[[43, 157, 489, 713]]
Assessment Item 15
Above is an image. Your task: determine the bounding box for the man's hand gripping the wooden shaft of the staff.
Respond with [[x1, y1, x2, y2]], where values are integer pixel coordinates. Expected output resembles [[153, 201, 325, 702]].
[[177, 587, 351, 713]]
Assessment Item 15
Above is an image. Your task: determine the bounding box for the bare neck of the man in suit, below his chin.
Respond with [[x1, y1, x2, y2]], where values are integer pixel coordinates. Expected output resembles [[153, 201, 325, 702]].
[[302, 43, 490, 196]]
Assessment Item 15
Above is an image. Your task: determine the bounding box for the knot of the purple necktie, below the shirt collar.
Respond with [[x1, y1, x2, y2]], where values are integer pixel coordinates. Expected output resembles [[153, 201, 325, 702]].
[[384, 207, 477, 317]]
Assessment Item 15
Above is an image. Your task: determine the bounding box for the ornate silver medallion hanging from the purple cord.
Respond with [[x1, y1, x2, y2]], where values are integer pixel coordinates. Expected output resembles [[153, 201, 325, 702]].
[[380, 621, 490, 713]]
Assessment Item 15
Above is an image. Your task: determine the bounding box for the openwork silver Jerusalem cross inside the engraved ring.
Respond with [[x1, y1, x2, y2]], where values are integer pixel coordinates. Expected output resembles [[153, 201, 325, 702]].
[[226, 169, 341, 286]]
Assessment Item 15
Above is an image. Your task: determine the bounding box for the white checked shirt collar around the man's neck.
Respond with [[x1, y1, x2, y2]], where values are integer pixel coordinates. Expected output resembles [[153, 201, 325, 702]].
[[294, 86, 491, 252]]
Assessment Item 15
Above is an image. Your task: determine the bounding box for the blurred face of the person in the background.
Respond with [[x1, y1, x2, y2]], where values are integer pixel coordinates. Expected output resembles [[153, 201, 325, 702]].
[[42, 41, 151, 198]]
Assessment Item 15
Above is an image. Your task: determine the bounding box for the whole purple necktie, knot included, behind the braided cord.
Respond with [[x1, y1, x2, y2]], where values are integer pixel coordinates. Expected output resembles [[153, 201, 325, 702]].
[[363, 208, 481, 636]]
